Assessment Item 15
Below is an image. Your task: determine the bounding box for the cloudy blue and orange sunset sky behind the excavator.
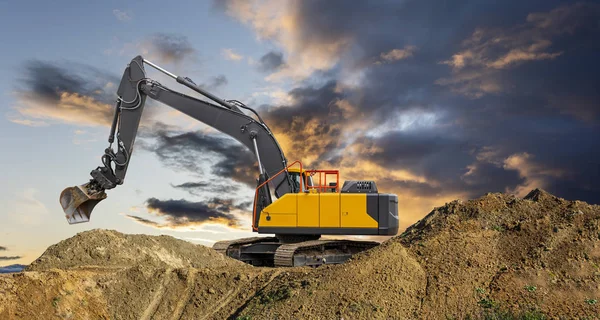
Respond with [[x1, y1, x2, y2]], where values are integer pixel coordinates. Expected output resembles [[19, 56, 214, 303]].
[[0, 0, 600, 266]]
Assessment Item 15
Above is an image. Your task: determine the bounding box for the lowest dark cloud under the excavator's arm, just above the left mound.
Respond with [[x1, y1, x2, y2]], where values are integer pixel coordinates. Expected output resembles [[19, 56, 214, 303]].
[[127, 198, 246, 230]]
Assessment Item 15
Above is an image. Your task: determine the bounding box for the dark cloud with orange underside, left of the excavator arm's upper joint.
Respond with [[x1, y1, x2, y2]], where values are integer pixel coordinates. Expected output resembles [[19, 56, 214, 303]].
[[7, 60, 117, 126]]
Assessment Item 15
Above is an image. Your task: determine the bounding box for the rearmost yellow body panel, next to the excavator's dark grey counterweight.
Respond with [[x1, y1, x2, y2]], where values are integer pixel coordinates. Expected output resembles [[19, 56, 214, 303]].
[[340, 193, 378, 228]]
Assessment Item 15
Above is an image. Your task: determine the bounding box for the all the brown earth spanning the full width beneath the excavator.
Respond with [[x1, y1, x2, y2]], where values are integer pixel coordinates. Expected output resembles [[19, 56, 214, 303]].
[[0, 189, 600, 319]]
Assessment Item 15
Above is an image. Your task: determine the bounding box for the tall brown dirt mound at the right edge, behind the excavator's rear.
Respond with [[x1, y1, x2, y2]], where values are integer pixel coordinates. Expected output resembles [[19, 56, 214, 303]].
[[390, 189, 600, 318]]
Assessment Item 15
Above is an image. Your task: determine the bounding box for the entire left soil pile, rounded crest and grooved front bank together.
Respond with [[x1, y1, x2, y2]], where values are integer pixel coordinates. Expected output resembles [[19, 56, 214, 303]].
[[0, 230, 280, 319]]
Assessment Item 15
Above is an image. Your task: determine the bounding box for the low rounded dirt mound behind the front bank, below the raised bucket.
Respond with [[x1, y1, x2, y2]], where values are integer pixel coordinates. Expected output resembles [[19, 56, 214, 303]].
[[26, 229, 245, 271]]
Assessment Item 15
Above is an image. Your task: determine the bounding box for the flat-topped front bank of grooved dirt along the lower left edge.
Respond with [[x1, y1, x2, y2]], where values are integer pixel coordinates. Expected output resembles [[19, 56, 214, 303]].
[[0, 265, 279, 319]]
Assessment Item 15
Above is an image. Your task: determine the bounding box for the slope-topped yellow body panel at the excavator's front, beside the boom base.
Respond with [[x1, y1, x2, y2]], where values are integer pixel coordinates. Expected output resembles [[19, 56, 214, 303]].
[[258, 193, 298, 227]]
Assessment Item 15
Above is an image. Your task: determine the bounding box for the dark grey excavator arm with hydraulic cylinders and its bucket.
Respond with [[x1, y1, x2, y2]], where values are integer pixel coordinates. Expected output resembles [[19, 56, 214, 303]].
[[60, 56, 297, 223]]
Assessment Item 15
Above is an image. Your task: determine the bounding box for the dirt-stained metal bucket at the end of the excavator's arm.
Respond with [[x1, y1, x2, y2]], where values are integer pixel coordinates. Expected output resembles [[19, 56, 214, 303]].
[[60, 183, 106, 224]]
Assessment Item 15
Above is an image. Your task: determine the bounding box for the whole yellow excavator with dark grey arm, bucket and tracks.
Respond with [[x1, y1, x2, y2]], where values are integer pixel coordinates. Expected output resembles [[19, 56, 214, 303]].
[[60, 56, 398, 267]]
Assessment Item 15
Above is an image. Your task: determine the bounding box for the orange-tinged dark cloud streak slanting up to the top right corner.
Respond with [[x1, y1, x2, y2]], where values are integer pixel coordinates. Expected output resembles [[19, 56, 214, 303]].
[[437, 3, 600, 98]]
